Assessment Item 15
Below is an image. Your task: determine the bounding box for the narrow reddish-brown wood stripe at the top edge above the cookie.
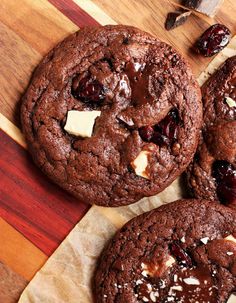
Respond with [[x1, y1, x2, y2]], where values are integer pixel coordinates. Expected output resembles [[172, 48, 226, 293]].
[[48, 0, 99, 28]]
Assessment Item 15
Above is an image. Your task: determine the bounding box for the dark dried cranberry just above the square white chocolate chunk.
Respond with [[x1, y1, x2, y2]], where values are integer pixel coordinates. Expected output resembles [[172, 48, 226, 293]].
[[71, 76, 105, 103]]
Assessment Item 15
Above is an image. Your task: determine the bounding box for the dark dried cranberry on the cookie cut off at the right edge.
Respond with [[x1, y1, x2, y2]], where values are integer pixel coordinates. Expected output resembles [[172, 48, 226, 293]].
[[212, 160, 236, 204]]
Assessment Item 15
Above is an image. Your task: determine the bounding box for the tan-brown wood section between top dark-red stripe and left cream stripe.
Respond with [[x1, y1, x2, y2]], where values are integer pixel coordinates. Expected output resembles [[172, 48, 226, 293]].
[[0, 0, 78, 126]]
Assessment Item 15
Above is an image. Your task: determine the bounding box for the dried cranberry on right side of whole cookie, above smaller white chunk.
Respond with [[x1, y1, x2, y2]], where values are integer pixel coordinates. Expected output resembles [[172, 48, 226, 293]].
[[139, 108, 179, 146]]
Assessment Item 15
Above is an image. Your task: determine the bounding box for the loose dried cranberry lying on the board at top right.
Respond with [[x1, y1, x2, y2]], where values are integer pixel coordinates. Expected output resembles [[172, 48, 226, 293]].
[[196, 24, 231, 57]]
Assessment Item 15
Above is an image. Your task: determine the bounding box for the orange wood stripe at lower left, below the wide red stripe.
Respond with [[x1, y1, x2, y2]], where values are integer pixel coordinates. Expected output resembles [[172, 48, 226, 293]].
[[0, 218, 47, 281]]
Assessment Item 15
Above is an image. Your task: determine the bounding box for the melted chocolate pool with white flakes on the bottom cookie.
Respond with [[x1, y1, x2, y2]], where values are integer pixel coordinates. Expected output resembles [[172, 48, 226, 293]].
[[134, 262, 218, 303]]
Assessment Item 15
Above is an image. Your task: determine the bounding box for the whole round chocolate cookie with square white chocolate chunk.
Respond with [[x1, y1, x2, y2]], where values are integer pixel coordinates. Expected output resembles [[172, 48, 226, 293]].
[[21, 25, 202, 206]]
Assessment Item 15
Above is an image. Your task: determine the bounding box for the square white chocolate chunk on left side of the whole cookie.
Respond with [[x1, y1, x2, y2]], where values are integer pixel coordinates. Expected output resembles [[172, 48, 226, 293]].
[[64, 110, 101, 137]]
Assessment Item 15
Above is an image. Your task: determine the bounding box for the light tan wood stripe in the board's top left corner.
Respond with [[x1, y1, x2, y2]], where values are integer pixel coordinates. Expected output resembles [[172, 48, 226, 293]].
[[0, 0, 78, 55]]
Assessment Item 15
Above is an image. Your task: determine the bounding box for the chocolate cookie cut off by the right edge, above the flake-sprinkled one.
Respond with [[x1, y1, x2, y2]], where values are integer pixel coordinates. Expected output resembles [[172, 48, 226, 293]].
[[187, 57, 236, 208]]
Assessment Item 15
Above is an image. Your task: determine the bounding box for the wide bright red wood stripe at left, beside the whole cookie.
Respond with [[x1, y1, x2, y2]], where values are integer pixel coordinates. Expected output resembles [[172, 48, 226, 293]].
[[0, 130, 89, 256]]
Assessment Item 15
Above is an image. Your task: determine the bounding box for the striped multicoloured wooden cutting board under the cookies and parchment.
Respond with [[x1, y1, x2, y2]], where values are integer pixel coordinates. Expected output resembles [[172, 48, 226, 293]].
[[0, 0, 236, 303]]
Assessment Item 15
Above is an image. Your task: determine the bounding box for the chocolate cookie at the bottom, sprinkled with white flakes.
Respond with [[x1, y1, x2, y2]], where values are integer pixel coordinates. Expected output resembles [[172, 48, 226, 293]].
[[94, 200, 236, 303]]
